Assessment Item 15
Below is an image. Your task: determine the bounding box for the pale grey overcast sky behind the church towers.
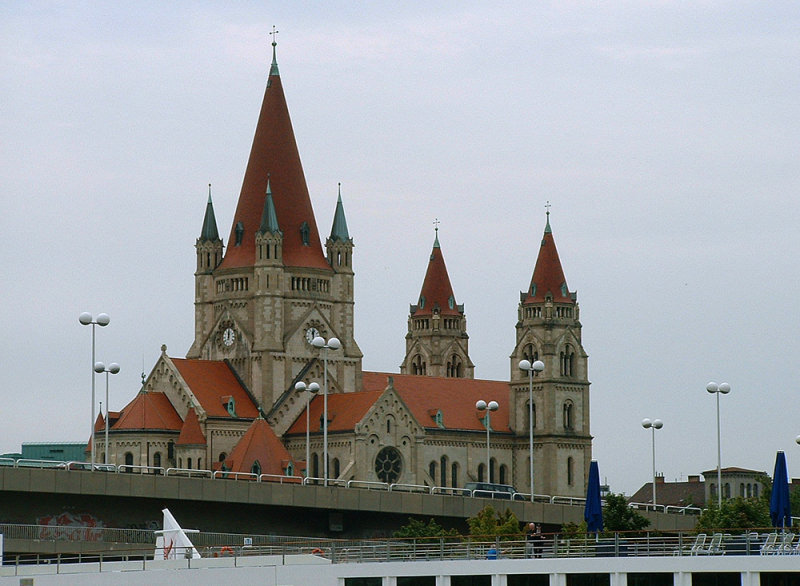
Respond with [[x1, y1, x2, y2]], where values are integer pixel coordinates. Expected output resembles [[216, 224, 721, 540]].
[[0, 0, 800, 494]]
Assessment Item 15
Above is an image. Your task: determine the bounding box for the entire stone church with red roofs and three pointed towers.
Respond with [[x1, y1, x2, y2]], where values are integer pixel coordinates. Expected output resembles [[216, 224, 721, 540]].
[[95, 42, 592, 496]]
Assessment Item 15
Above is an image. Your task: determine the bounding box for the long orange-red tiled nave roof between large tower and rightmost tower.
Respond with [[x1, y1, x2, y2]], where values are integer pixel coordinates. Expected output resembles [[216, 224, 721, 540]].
[[286, 372, 511, 435]]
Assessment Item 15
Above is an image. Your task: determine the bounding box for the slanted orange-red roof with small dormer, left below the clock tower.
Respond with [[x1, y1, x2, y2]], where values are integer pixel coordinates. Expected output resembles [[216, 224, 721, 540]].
[[171, 358, 258, 419]]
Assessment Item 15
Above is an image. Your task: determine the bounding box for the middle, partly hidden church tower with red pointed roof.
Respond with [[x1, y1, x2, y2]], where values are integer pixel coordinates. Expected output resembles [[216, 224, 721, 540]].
[[400, 220, 475, 378]]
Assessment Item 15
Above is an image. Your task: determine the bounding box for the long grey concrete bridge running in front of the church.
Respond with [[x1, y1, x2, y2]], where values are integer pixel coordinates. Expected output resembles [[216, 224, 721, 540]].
[[0, 466, 696, 552]]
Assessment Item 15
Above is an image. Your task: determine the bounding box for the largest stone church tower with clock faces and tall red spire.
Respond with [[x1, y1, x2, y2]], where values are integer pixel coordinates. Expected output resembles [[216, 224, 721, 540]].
[[187, 42, 362, 424]]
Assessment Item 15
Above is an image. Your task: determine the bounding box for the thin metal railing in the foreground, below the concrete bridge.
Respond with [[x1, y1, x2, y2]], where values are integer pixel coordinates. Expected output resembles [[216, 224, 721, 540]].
[[0, 524, 790, 569]]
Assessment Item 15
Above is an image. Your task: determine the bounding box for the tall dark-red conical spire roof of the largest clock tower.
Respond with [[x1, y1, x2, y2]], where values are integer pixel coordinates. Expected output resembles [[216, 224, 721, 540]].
[[220, 60, 330, 270]]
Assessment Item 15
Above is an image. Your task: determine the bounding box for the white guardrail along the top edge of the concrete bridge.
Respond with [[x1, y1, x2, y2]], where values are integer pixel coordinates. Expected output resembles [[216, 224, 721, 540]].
[[0, 458, 702, 515]]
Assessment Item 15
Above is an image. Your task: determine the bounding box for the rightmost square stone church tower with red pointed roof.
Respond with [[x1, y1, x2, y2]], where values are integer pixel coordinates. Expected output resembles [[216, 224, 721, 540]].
[[510, 204, 592, 496]]
